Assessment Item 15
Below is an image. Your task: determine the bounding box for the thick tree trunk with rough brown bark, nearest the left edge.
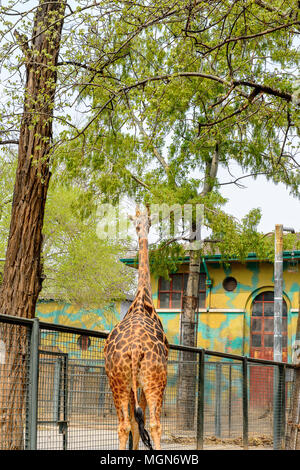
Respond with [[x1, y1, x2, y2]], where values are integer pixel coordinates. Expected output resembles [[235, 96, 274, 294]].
[[0, 0, 65, 449]]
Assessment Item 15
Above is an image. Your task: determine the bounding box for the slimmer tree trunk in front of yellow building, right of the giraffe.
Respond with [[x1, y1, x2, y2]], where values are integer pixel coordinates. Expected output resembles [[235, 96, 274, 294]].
[[177, 144, 219, 430]]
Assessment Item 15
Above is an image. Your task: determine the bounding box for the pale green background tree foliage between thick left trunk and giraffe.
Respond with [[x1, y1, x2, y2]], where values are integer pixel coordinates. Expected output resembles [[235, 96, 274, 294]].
[[0, 158, 134, 308]]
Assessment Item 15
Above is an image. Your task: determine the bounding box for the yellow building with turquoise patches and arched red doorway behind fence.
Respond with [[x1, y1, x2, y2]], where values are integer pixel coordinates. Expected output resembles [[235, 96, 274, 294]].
[[36, 251, 300, 362]]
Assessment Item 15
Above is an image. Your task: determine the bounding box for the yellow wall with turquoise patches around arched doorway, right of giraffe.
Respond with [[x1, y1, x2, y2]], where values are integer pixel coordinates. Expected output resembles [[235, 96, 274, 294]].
[[153, 261, 300, 361]]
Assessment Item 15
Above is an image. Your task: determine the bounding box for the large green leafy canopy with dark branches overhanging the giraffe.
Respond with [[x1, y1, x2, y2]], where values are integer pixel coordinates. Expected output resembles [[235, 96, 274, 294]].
[[1, 0, 299, 278]]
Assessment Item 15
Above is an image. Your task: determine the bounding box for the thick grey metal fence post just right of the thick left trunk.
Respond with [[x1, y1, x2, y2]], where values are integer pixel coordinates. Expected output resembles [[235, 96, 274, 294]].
[[28, 318, 40, 450]]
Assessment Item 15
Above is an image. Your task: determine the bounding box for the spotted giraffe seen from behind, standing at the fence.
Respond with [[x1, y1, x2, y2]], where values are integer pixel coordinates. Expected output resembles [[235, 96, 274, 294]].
[[104, 209, 169, 450]]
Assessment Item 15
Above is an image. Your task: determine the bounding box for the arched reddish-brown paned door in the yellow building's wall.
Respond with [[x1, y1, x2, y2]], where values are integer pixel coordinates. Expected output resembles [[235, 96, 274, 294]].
[[250, 291, 287, 361]]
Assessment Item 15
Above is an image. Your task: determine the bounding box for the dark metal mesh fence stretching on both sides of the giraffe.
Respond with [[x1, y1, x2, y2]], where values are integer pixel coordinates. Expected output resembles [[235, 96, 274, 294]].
[[0, 315, 294, 450]]
